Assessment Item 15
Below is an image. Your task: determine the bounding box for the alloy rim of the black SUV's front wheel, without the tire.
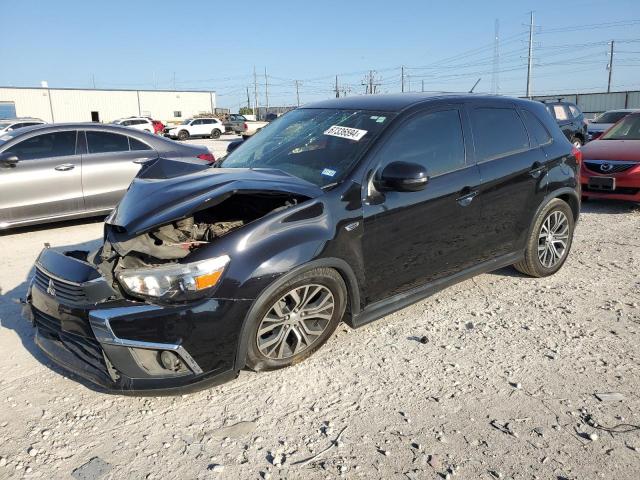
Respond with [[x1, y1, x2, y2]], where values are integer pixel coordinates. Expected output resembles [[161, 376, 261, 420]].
[[256, 284, 335, 360]]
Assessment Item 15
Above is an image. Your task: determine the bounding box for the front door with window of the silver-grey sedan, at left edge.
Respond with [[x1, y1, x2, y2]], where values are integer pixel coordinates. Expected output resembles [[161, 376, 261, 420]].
[[0, 130, 83, 223]]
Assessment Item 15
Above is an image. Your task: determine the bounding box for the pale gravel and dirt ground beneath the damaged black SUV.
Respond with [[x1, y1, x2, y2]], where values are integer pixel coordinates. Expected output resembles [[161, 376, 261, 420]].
[[0, 189, 640, 480]]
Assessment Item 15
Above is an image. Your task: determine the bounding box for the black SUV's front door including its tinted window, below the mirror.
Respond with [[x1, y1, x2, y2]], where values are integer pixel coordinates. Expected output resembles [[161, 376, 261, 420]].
[[363, 106, 481, 303]]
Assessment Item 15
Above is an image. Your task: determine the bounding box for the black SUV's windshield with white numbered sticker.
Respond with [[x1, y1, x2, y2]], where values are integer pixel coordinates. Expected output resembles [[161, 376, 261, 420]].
[[221, 108, 395, 187]]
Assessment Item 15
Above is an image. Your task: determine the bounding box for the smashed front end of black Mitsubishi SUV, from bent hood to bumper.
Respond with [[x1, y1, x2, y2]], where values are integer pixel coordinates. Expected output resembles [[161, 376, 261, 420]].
[[28, 169, 320, 393]]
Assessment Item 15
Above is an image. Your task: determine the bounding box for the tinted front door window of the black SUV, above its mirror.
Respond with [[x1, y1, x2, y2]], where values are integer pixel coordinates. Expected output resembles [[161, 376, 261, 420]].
[[379, 110, 465, 177]]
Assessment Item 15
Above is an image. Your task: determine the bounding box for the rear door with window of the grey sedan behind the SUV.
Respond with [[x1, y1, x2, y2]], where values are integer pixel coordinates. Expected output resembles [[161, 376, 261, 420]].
[[81, 130, 158, 210]]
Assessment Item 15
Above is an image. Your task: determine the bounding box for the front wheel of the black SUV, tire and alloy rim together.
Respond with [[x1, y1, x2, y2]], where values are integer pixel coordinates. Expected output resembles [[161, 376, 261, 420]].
[[245, 268, 347, 371]]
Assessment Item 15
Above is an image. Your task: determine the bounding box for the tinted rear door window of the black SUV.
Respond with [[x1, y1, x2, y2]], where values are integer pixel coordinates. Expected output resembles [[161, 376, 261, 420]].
[[471, 108, 529, 162]]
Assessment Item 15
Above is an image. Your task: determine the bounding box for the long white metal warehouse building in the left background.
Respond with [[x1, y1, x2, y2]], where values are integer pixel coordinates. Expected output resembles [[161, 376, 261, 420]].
[[0, 87, 216, 122]]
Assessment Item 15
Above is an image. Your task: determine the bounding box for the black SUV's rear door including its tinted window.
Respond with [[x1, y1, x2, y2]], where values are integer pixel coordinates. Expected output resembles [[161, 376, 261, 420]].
[[469, 103, 547, 260]]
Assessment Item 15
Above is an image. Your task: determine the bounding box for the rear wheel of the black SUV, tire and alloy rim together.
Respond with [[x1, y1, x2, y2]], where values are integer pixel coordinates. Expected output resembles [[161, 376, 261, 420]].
[[514, 198, 575, 277]]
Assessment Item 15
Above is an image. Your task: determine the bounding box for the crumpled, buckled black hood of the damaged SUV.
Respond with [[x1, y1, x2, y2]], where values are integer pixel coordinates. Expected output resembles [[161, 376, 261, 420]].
[[106, 162, 323, 235]]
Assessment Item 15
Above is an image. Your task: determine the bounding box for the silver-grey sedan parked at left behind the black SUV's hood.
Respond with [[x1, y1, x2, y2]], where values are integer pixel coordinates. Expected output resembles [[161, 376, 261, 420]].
[[0, 123, 214, 229]]
